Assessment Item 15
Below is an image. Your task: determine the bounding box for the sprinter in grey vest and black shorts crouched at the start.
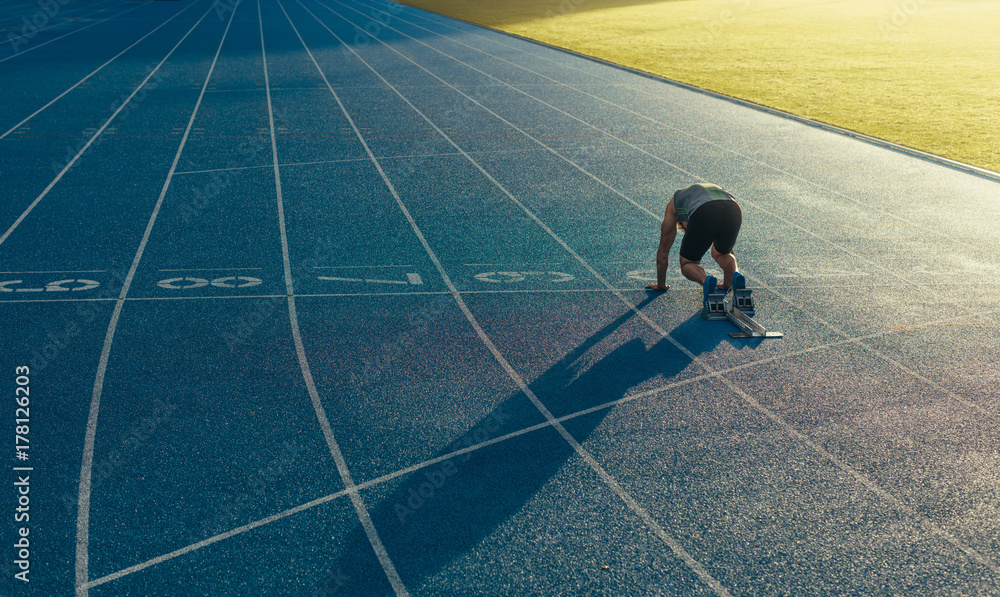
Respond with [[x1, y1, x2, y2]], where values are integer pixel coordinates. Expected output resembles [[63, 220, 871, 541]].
[[646, 183, 746, 303]]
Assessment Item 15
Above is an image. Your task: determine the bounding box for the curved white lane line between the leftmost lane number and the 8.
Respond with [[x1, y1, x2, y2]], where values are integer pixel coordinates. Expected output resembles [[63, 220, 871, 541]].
[[76, 2, 238, 597]]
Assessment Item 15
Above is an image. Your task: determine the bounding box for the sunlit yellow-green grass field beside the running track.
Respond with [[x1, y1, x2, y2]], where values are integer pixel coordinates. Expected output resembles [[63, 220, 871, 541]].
[[394, 0, 1000, 172]]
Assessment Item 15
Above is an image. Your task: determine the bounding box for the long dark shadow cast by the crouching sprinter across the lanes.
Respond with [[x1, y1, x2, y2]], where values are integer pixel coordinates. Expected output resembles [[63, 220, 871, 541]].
[[313, 297, 719, 595]]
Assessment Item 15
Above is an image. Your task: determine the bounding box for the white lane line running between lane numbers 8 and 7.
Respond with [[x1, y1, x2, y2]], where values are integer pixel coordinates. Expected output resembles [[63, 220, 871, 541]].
[[257, 0, 410, 597]]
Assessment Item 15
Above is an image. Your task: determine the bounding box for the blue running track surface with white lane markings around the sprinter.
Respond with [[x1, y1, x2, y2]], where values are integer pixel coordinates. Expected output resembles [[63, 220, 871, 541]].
[[0, 0, 1000, 597]]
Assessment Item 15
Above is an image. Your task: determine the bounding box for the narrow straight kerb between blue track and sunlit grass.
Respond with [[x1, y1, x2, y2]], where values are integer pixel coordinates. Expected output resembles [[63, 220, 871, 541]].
[[390, 0, 1000, 182]]
